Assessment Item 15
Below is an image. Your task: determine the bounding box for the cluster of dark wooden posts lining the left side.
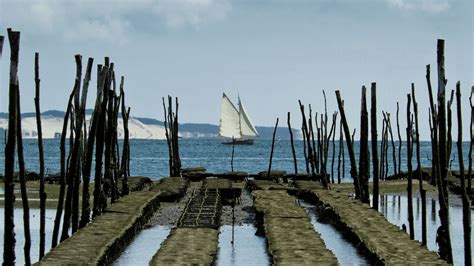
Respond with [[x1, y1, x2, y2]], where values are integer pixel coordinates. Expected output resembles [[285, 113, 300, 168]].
[[0, 29, 130, 265]]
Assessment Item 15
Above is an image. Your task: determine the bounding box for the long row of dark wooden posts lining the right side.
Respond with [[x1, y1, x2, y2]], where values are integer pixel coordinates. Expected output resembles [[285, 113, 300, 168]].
[[268, 40, 474, 265]]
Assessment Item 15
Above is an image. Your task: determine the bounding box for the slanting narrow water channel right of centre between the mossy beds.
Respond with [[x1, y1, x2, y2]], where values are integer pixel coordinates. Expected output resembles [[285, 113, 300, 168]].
[[300, 200, 370, 265]]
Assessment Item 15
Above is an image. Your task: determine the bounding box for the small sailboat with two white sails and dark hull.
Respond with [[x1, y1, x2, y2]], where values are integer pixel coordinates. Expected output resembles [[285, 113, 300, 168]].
[[219, 93, 258, 145]]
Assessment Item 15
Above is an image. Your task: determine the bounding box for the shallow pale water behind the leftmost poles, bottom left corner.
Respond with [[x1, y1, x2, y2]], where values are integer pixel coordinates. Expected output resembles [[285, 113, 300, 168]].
[[0, 208, 61, 265]]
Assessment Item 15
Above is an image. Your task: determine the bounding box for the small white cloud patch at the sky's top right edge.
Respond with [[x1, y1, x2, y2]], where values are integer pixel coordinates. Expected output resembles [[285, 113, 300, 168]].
[[386, 0, 451, 13]]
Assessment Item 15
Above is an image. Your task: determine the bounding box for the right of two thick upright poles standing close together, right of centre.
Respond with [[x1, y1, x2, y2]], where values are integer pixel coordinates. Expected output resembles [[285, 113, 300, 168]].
[[370, 82, 379, 210]]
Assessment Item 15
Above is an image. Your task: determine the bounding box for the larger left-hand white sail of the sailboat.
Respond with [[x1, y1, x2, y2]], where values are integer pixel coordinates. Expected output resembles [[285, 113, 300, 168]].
[[219, 93, 242, 138]]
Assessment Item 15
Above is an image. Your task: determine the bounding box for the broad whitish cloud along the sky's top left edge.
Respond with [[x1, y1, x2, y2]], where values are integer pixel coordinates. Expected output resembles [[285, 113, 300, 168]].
[[0, 0, 231, 43]]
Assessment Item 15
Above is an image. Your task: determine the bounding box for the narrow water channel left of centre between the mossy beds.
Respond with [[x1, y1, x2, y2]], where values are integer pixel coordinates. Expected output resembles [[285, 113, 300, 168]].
[[113, 225, 171, 266]]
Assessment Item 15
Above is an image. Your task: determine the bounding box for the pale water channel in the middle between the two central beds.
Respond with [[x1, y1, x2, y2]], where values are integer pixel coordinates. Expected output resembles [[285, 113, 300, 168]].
[[216, 224, 270, 265]]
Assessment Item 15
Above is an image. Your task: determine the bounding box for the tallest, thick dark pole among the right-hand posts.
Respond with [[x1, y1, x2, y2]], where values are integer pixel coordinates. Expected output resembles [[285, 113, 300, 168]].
[[437, 39, 453, 263]]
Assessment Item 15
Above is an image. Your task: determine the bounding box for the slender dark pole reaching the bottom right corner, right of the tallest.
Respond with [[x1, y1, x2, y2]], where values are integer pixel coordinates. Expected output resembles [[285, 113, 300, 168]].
[[456, 81, 472, 266]]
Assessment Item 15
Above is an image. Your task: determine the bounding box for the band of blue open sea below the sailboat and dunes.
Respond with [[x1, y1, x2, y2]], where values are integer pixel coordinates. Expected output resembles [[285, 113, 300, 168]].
[[0, 138, 469, 182]]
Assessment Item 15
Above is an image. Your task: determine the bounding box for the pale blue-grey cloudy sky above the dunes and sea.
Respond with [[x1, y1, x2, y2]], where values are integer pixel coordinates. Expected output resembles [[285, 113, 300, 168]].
[[0, 0, 474, 140]]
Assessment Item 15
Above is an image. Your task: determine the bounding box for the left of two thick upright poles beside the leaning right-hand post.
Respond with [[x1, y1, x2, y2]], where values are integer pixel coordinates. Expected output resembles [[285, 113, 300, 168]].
[[359, 86, 370, 204]]
